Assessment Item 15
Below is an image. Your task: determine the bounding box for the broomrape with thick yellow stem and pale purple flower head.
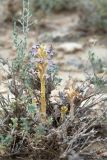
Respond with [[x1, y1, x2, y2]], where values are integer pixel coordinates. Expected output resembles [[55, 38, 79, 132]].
[[32, 44, 54, 120]]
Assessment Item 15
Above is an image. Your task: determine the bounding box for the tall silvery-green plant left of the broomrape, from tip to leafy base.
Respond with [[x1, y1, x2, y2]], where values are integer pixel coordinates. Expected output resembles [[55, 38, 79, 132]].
[[0, 0, 31, 152]]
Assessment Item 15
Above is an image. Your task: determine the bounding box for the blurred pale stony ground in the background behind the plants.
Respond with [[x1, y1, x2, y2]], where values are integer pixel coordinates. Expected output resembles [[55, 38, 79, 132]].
[[0, 13, 107, 93]]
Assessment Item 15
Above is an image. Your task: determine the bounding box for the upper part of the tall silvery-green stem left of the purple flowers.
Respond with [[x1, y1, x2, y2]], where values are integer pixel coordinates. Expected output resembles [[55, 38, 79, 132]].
[[13, 0, 31, 70]]
